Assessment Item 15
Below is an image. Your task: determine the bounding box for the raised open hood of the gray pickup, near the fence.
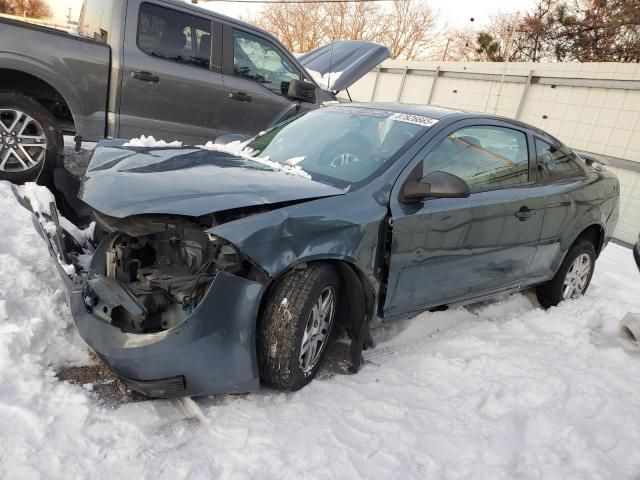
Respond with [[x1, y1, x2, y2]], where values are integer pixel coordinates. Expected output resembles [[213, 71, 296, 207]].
[[298, 40, 391, 91]]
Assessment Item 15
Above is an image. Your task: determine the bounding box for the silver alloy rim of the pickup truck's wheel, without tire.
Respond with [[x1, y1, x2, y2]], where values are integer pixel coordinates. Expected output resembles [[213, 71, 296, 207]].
[[0, 109, 47, 172]]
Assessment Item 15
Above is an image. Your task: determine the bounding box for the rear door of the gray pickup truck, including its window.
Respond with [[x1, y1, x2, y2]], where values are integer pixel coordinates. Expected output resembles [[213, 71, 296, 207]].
[[117, 0, 224, 144]]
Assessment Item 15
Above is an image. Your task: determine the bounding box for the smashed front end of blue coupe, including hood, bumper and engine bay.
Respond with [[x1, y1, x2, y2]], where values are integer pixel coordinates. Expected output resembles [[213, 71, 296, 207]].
[[14, 141, 340, 397]]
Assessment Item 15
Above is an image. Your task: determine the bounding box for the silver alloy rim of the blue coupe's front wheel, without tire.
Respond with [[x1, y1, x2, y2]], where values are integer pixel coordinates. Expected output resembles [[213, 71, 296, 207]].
[[298, 286, 336, 373]]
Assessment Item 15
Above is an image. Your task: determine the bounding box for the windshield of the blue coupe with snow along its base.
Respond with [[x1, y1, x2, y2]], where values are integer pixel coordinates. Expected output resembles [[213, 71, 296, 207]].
[[247, 106, 435, 188]]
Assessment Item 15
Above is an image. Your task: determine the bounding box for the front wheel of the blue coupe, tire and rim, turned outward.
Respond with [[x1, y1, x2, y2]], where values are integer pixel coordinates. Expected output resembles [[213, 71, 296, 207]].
[[257, 263, 340, 391]]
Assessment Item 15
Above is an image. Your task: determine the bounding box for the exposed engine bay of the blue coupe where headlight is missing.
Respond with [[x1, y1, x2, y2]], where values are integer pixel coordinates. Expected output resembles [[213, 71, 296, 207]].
[[85, 212, 252, 333]]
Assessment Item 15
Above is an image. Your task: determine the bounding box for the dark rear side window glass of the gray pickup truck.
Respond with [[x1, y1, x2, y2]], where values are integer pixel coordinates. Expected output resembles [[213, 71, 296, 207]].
[[138, 3, 211, 68]]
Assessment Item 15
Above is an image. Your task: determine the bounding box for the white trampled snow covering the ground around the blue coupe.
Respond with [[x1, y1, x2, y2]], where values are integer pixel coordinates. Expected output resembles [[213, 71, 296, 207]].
[[0, 183, 640, 480]]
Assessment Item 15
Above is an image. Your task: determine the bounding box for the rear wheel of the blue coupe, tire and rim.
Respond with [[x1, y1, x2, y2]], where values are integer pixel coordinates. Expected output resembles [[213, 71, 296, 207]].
[[536, 238, 596, 308]]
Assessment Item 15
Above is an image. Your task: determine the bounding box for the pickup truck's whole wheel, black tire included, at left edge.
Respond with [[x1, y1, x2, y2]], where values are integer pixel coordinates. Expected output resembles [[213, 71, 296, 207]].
[[0, 92, 64, 183]]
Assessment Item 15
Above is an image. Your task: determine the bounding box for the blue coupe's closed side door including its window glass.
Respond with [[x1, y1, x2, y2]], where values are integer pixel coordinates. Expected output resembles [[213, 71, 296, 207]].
[[384, 120, 545, 317]]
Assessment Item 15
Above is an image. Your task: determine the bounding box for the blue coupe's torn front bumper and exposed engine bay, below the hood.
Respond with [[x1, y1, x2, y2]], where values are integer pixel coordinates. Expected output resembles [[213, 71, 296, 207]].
[[16, 190, 265, 397]]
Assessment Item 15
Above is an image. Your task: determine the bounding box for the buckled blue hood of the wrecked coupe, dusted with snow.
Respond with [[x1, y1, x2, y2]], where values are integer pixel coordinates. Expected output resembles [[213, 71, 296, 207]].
[[78, 140, 344, 218]]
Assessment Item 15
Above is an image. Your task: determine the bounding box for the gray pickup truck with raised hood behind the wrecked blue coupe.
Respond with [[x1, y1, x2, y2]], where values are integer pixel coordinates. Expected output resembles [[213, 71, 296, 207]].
[[0, 0, 390, 183]]
